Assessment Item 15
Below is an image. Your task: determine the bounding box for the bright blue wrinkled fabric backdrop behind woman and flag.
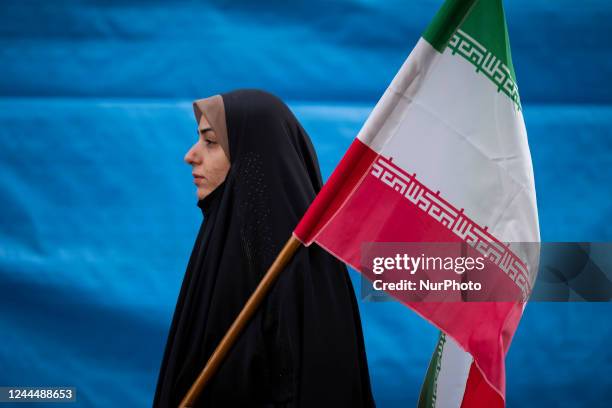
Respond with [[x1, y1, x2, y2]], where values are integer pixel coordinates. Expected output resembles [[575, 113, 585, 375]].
[[0, 0, 612, 407]]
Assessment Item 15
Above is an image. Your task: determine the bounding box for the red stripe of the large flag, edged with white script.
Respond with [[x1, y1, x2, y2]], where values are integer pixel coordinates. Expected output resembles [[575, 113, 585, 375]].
[[294, 139, 522, 403]]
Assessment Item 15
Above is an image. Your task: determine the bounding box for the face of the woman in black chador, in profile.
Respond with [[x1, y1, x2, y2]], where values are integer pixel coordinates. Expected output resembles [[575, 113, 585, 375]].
[[185, 115, 230, 200]]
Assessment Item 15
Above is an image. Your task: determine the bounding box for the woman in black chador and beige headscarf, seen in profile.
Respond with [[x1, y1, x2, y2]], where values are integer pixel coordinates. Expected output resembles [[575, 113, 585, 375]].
[[153, 90, 374, 407]]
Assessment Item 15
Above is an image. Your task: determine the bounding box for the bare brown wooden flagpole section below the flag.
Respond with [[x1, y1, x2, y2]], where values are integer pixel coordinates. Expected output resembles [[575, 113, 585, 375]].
[[179, 235, 301, 408]]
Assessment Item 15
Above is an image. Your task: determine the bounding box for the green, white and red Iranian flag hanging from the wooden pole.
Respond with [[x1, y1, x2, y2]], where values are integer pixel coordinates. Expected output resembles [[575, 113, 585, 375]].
[[294, 0, 539, 407]]
